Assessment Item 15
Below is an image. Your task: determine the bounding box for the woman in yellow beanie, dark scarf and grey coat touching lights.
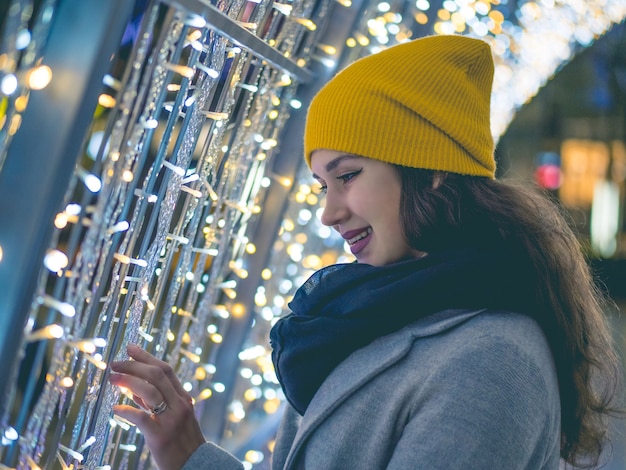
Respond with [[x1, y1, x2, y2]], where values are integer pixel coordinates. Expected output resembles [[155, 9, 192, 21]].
[[110, 36, 619, 470]]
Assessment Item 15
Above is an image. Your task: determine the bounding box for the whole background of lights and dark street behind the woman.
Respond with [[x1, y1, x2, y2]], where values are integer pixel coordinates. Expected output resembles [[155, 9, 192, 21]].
[[0, 0, 626, 470]]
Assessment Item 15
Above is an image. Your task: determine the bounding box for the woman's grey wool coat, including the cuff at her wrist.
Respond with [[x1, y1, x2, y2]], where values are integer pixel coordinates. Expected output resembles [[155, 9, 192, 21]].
[[183, 310, 560, 470]]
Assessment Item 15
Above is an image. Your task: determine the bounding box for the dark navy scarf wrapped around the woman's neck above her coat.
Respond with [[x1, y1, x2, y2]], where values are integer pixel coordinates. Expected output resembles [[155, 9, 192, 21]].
[[270, 248, 536, 414]]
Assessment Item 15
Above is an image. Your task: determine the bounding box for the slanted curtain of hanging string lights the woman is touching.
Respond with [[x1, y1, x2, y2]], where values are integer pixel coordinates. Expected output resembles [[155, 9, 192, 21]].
[[0, 0, 330, 469]]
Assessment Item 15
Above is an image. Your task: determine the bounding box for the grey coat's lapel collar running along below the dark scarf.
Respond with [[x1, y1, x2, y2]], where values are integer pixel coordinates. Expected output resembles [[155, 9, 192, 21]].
[[284, 309, 484, 469]]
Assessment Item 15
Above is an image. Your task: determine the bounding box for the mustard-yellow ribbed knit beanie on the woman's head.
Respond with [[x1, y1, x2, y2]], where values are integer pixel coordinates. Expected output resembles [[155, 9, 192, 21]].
[[304, 36, 496, 178]]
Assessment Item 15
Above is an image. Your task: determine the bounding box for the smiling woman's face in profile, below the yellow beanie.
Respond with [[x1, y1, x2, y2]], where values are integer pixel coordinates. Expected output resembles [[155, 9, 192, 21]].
[[311, 150, 418, 266]]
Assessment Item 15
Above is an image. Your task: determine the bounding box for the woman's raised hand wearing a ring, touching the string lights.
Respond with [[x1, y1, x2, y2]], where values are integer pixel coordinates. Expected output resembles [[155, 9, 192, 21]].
[[109, 345, 205, 470]]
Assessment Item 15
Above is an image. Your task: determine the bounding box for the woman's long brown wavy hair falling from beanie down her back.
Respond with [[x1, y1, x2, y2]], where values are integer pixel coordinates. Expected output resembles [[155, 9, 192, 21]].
[[394, 165, 621, 468]]
